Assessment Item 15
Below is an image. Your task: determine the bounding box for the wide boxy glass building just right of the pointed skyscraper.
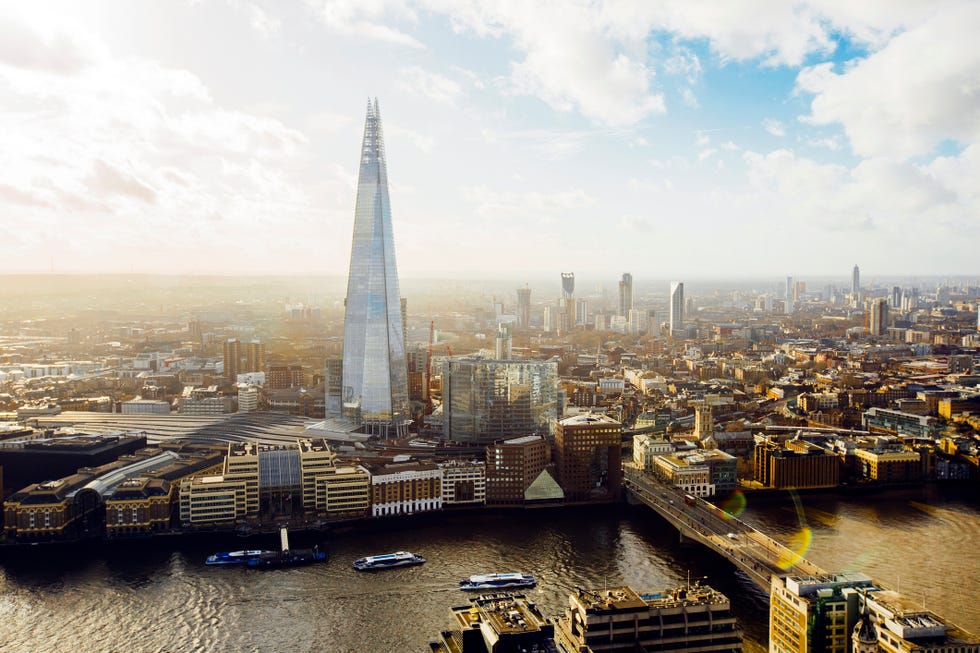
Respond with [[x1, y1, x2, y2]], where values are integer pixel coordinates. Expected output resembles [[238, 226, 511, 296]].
[[442, 358, 558, 443]]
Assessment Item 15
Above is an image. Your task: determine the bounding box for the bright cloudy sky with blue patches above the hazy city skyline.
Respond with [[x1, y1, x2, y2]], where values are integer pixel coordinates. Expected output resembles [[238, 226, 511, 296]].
[[0, 0, 980, 280]]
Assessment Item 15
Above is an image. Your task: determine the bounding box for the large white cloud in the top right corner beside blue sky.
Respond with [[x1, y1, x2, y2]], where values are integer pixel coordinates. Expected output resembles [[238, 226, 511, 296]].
[[797, 2, 980, 158]]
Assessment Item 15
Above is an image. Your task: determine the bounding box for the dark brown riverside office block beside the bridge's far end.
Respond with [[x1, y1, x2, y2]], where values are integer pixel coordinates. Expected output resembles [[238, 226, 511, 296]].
[[555, 413, 623, 501]]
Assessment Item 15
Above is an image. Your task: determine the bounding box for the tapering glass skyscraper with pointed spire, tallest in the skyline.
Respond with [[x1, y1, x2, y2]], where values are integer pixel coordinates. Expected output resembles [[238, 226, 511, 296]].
[[341, 100, 410, 437]]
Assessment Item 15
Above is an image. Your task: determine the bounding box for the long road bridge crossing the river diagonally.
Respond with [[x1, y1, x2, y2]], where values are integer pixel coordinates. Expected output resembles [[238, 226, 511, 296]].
[[623, 463, 827, 595]]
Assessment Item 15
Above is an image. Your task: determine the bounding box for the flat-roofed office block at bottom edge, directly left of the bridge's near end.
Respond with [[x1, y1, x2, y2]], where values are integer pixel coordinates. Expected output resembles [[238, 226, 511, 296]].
[[555, 584, 742, 653]]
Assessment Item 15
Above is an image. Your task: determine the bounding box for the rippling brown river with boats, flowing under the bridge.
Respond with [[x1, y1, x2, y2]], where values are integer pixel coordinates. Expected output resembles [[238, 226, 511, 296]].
[[0, 488, 980, 653]]
